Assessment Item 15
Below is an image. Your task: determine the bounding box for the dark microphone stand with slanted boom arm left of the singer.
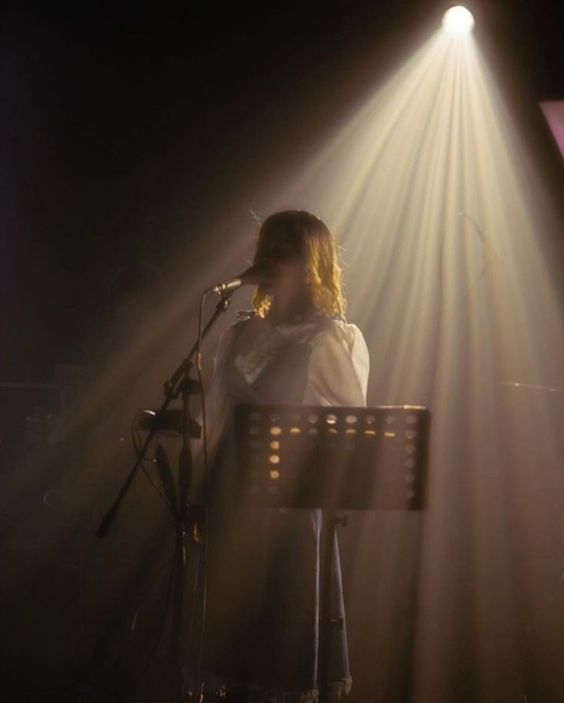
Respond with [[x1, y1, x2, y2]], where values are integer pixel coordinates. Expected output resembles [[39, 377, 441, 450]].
[[96, 289, 235, 702]]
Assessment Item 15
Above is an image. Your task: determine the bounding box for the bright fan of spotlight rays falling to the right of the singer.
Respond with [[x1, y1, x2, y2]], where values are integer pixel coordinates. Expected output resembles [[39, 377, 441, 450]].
[[267, 23, 564, 702]]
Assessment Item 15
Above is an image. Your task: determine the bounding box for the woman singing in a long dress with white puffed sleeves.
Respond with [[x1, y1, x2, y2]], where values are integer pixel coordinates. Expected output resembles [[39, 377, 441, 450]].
[[195, 211, 369, 703]]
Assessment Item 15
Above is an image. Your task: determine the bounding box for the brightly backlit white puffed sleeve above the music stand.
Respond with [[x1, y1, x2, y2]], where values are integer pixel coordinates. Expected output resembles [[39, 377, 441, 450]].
[[302, 321, 369, 406]]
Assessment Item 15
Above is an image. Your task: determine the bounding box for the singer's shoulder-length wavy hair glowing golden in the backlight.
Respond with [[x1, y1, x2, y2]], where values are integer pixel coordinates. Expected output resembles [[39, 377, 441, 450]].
[[253, 210, 346, 318]]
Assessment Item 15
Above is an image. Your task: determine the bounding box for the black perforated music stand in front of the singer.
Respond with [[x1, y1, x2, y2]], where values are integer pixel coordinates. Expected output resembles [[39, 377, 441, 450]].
[[235, 405, 430, 703]]
